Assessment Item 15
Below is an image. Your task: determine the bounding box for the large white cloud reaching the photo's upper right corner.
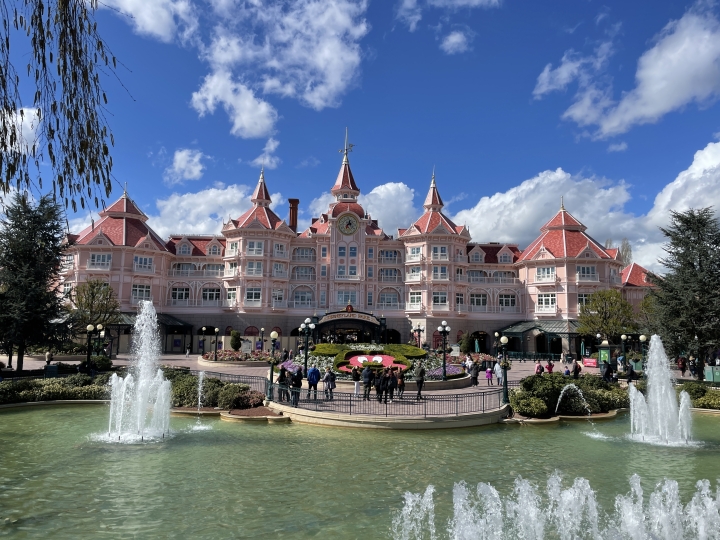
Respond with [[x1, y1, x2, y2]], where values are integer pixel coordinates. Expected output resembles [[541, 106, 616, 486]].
[[533, 3, 720, 139]]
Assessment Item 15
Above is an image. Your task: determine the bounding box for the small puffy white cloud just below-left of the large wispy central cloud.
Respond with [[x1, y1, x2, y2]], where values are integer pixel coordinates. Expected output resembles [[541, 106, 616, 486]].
[[192, 71, 278, 138]]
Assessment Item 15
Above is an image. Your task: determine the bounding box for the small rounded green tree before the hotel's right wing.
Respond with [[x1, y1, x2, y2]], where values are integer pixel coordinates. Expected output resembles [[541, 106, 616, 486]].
[[577, 289, 636, 340]]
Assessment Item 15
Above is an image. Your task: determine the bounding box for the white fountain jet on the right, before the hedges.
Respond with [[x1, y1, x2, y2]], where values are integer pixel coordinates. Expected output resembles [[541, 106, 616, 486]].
[[629, 335, 691, 445]]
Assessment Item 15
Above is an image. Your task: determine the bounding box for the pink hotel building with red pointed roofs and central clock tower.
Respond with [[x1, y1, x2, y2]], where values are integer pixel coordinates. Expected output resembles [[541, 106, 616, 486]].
[[61, 152, 648, 354]]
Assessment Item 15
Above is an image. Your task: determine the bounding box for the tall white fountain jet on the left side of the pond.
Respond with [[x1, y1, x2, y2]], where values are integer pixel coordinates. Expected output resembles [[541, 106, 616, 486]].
[[107, 302, 170, 442]]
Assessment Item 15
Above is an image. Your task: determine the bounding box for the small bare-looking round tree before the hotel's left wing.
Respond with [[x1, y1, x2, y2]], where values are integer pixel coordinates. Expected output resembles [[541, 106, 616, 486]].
[[71, 279, 120, 335]]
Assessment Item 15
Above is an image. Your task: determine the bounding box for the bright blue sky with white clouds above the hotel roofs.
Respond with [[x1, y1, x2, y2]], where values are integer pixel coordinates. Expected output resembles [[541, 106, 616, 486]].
[[12, 0, 720, 267]]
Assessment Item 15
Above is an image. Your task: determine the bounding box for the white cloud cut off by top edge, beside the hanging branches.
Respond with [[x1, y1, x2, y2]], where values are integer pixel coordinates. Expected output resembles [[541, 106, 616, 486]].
[[100, 0, 198, 42]]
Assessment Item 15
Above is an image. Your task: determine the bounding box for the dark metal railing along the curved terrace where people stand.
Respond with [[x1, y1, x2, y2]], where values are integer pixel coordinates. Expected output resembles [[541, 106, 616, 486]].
[[266, 384, 502, 418]]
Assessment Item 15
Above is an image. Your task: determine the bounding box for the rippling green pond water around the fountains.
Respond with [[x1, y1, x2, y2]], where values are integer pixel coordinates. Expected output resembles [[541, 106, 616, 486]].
[[0, 406, 720, 539]]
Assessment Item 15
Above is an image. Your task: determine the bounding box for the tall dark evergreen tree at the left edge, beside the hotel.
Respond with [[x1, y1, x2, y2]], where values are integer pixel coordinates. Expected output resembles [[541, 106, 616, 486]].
[[0, 193, 67, 371]]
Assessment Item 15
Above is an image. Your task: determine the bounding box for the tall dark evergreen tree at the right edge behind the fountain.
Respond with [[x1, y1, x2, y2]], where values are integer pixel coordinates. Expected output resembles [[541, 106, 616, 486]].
[[648, 208, 720, 378]]
